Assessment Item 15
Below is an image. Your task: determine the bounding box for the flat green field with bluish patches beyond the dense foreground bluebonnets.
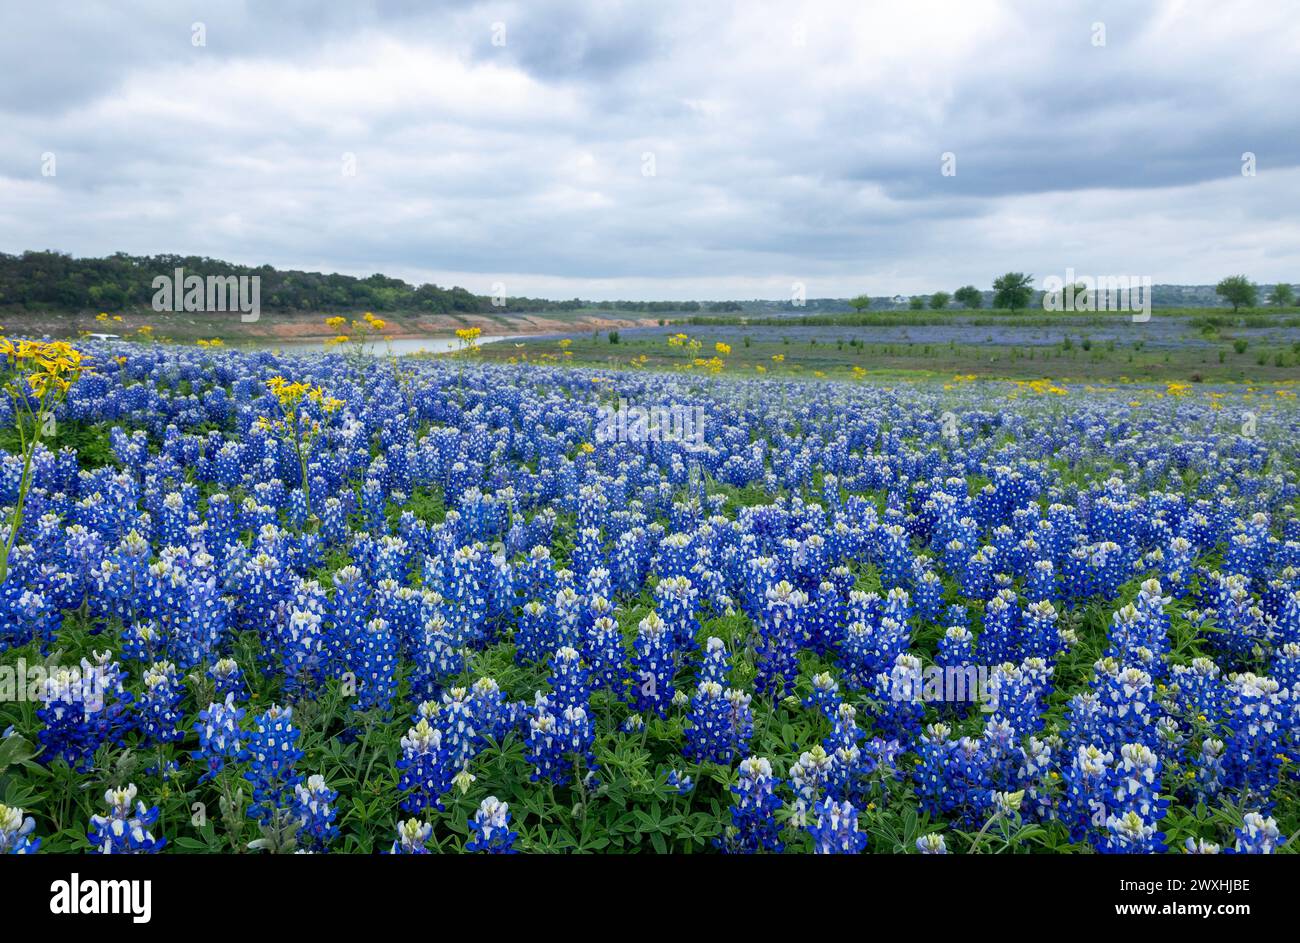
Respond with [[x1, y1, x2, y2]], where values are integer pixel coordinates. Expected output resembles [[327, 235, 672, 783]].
[[481, 315, 1300, 384]]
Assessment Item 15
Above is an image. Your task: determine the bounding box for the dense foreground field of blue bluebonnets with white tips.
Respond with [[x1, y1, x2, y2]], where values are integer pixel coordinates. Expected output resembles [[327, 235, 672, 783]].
[[0, 332, 1300, 853]]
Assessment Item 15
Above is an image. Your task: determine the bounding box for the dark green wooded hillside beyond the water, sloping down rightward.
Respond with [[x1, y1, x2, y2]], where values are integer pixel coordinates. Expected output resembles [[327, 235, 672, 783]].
[[0, 252, 741, 315]]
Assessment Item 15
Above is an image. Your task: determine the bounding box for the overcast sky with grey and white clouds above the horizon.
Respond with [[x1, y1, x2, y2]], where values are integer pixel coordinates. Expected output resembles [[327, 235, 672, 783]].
[[0, 0, 1300, 299]]
